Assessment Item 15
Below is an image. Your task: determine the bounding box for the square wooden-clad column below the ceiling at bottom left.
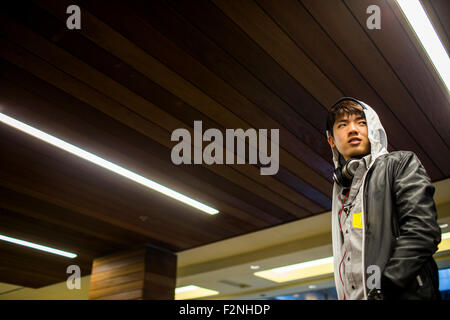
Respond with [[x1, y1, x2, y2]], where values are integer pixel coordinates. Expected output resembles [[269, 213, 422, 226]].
[[89, 245, 177, 300]]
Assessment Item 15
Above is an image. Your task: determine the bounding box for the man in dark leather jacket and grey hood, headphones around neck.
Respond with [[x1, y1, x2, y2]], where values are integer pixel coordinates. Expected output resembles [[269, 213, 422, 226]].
[[327, 98, 441, 300]]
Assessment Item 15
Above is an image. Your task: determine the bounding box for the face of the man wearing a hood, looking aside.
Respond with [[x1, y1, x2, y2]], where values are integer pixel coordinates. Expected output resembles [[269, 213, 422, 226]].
[[328, 106, 370, 161]]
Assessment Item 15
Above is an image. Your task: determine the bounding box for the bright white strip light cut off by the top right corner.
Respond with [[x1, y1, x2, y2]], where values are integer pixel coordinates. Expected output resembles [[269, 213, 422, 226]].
[[397, 0, 450, 90]]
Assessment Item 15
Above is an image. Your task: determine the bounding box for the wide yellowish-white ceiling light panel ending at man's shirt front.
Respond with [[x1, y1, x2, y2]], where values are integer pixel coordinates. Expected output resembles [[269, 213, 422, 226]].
[[254, 257, 333, 283]]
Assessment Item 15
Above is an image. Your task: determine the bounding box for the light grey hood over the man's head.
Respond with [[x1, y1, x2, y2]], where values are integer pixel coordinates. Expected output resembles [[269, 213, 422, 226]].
[[327, 97, 388, 168]]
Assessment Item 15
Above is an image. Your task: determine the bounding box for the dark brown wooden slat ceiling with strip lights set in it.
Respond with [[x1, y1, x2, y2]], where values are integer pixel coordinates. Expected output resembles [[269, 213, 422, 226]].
[[0, 0, 450, 287]]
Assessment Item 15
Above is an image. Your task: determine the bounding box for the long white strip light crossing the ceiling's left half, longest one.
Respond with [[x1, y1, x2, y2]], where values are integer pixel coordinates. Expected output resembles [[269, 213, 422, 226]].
[[0, 113, 219, 214]]
